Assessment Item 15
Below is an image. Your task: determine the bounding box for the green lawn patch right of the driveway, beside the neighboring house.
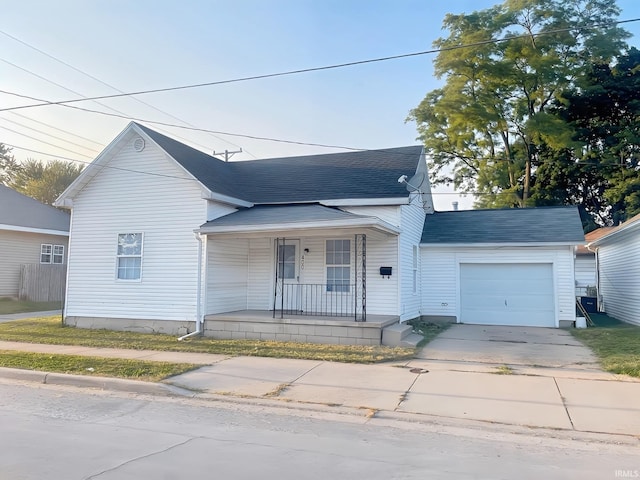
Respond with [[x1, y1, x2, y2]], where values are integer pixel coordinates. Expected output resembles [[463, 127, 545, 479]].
[[571, 314, 640, 377]]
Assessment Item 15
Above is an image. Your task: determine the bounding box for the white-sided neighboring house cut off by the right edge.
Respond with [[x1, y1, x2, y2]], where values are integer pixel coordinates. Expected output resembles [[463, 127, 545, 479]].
[[588, 215, 640, 325]]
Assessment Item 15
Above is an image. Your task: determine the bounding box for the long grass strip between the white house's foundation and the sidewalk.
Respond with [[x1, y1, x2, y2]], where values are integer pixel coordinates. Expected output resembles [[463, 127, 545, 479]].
[[0, 317, 415, 363]]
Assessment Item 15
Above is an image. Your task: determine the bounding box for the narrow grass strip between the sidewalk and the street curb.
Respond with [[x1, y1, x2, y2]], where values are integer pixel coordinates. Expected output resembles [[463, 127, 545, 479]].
[[0, 350, 197, 382]]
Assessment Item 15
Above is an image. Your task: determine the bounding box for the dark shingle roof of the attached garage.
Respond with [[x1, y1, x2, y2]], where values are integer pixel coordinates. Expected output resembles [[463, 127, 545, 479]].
[[421, 207, 584, 245]]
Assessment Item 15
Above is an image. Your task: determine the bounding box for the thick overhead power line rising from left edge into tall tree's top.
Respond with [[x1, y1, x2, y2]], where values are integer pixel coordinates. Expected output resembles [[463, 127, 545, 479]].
[[0, 18, 640, 112]]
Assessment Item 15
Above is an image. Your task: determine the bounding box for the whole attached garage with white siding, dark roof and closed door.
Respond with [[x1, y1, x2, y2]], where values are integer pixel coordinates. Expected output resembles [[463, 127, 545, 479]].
[[420, 207, 584, 327]]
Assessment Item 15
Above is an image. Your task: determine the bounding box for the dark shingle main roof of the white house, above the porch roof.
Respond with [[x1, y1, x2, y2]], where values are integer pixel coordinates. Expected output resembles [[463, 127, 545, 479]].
[[136, 124, 422, 203]]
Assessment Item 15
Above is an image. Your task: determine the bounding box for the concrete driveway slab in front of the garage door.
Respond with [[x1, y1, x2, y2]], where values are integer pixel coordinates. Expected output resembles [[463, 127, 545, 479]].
[[418, 324, 610, 378]]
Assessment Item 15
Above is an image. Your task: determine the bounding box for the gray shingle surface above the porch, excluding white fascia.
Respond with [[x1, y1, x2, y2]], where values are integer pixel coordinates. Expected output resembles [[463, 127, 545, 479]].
[[202, 203, 376, 228]]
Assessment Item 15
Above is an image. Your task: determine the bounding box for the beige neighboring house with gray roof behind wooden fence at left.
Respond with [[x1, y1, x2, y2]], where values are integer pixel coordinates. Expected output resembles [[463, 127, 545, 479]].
[[0, 185, 70, 297]]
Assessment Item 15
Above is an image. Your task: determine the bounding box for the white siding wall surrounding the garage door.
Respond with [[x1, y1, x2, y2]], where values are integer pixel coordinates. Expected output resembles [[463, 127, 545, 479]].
[[420, 245, 575, 326]]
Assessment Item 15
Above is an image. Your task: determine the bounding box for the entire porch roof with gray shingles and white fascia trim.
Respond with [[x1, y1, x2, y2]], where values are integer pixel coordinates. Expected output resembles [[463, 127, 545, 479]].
[[199, 204, 400, 235]]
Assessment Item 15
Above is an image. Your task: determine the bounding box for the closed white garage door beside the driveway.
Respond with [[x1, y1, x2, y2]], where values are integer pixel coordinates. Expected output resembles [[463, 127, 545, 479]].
[[460, 263, 556, 327]]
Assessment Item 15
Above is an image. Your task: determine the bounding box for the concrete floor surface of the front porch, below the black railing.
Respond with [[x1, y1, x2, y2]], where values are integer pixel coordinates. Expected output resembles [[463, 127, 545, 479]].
[[204, 310, 400, 328]]
